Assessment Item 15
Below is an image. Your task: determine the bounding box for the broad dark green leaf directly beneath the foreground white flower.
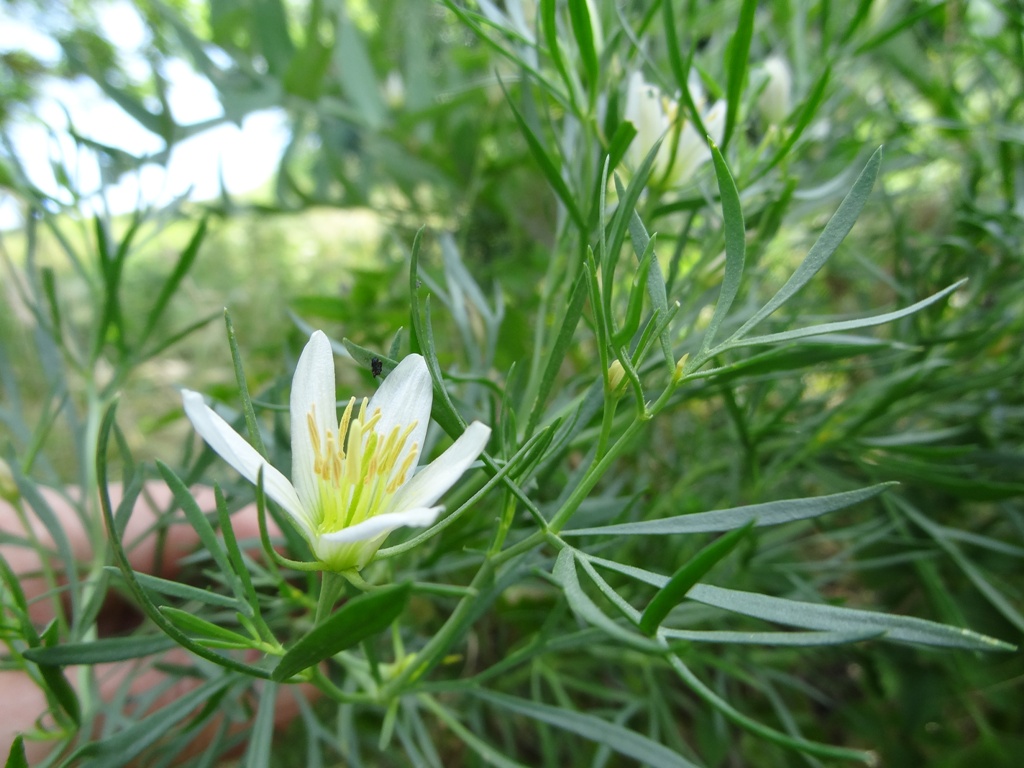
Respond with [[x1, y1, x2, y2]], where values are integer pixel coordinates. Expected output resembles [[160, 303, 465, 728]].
[[271, 582, 413, 681]]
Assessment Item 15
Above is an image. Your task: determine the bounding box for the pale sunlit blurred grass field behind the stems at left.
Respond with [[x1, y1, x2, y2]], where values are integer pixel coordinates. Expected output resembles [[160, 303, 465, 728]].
[[0, 210, 385, 468]]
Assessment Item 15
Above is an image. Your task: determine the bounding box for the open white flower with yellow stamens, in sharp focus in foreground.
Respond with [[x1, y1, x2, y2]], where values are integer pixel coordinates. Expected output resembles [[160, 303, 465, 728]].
[[181, 331, 490, 570]]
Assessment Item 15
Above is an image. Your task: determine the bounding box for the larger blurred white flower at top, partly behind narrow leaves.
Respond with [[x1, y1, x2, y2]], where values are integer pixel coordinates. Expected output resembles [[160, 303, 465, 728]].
[[623, 72, 725, 186]]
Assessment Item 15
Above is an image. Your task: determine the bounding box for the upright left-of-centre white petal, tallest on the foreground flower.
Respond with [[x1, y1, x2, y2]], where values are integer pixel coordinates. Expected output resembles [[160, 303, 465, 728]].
[[291, 331, 338, 518]]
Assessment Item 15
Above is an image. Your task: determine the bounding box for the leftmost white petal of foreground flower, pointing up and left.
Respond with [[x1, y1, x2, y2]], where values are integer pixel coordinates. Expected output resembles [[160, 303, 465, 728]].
[[181, 389, 312, 536]]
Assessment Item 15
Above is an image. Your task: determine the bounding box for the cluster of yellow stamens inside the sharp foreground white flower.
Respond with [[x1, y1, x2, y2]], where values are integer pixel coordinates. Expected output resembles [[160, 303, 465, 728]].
[[306, 397, 420, 534]]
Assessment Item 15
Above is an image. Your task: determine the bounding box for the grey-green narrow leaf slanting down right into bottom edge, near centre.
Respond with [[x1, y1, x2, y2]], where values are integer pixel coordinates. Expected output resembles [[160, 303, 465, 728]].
[[470, 690, 697, 768]]
